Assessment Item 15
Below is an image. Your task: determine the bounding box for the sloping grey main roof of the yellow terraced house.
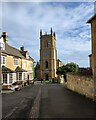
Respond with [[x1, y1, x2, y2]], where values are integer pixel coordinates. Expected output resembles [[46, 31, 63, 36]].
[[2, 43, 34, 61]]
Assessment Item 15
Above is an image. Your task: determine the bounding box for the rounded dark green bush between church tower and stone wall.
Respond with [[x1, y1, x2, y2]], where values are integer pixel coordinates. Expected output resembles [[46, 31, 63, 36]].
[[56, 62, 79, 75]]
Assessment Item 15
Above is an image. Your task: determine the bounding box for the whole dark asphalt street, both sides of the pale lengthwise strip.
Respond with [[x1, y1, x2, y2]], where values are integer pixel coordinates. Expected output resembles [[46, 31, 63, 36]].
[[2, 83, 96, 118]]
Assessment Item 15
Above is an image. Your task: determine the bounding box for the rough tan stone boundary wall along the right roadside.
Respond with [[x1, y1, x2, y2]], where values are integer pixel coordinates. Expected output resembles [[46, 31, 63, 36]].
[[67, 73, 94, 99]]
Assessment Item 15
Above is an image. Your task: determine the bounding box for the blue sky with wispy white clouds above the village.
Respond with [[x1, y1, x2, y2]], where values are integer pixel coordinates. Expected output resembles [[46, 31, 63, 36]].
[[1, 2, 94, 67]]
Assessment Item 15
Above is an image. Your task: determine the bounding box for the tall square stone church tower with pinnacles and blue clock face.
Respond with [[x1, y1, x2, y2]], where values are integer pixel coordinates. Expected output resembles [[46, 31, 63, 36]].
[[40, 28, 57, 80]]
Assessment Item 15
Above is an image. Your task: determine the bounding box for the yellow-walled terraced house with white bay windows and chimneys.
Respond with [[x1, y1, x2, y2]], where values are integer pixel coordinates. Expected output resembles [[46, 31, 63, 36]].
[[0, 32, 34, 84]]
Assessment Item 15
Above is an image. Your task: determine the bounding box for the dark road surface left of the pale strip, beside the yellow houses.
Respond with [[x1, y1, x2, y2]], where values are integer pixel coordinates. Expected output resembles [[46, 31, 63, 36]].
[[2, 85, 39, 118]]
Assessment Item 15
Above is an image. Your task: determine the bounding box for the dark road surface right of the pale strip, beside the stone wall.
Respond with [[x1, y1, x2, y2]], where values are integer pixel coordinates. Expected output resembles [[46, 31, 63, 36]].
[[40, 84, 96, 118]]
